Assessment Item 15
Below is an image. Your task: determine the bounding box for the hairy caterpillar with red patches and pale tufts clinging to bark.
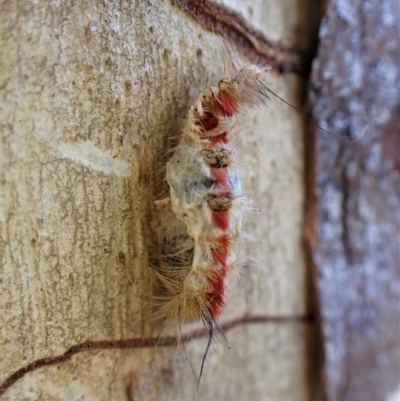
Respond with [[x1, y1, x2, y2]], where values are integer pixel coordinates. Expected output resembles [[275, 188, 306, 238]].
[[156, 51, 269, 333]]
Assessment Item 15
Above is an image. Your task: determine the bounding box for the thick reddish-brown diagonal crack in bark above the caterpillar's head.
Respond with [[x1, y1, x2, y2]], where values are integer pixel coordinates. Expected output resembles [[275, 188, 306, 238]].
[[173, 0, 313, 77]]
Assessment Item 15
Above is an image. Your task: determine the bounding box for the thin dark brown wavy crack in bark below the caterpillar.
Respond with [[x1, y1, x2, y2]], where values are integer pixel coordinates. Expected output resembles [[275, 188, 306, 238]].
[[0, 315, 313, 396]]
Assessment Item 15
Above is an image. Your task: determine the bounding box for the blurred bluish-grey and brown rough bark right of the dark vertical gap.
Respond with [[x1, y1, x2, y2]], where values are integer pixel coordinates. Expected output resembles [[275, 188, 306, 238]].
[[311, 0, 400, 401]]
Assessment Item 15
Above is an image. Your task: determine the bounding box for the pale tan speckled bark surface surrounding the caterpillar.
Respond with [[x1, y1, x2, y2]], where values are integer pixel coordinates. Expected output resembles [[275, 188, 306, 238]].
[[0, 0, 318, 401]]
